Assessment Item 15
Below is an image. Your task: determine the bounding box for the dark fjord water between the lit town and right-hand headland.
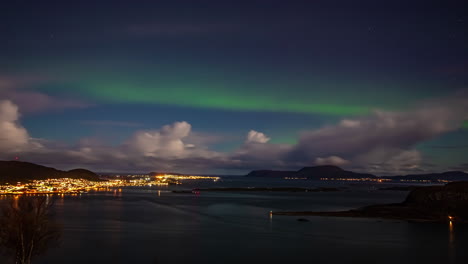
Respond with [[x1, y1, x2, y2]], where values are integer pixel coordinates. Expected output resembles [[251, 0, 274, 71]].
[[20, 177, 468, 264]]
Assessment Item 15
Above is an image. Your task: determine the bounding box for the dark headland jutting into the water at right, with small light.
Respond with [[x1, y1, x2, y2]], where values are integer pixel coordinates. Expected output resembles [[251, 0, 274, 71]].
[[272, 182, 468, 223]]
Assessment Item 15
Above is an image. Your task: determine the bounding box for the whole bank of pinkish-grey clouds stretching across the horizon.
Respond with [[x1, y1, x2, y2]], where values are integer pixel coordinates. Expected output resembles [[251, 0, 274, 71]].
[[0, 95, 468, 175]]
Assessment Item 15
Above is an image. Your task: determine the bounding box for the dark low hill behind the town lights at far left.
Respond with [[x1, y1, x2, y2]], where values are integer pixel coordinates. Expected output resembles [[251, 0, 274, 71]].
[[0, 161, 99, 183]]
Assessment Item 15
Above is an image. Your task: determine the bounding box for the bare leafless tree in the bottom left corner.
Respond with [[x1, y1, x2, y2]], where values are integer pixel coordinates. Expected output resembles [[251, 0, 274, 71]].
[[0, 196, 61, 264]]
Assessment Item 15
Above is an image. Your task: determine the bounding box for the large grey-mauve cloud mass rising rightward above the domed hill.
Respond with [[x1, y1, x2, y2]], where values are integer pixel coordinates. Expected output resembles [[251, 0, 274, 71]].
[[287, 97, 468, 172]]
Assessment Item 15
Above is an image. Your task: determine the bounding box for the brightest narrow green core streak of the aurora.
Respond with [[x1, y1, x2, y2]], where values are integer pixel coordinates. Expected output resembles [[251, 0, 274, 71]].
[[81, 83, 370, 115]]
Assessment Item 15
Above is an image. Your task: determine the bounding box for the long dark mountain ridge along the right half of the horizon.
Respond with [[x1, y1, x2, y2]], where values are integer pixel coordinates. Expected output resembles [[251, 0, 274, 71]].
[[246, 165, 468, 181]]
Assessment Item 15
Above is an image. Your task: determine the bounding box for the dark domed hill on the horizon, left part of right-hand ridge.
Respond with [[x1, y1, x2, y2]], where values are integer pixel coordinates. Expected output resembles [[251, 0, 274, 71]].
[[246, 165, 377, 179]]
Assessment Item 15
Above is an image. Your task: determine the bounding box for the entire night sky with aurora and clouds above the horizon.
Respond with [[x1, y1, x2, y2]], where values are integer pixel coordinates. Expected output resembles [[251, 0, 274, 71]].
[[0, 0, 468, 175]]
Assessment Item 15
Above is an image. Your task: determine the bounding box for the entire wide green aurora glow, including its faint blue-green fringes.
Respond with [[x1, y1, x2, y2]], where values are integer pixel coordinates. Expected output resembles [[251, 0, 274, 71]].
[[28, 64, 446, 116]]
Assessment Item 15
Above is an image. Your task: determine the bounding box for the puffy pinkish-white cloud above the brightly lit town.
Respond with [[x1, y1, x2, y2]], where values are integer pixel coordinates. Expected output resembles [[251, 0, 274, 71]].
[[43, 121, 224, 170]]
